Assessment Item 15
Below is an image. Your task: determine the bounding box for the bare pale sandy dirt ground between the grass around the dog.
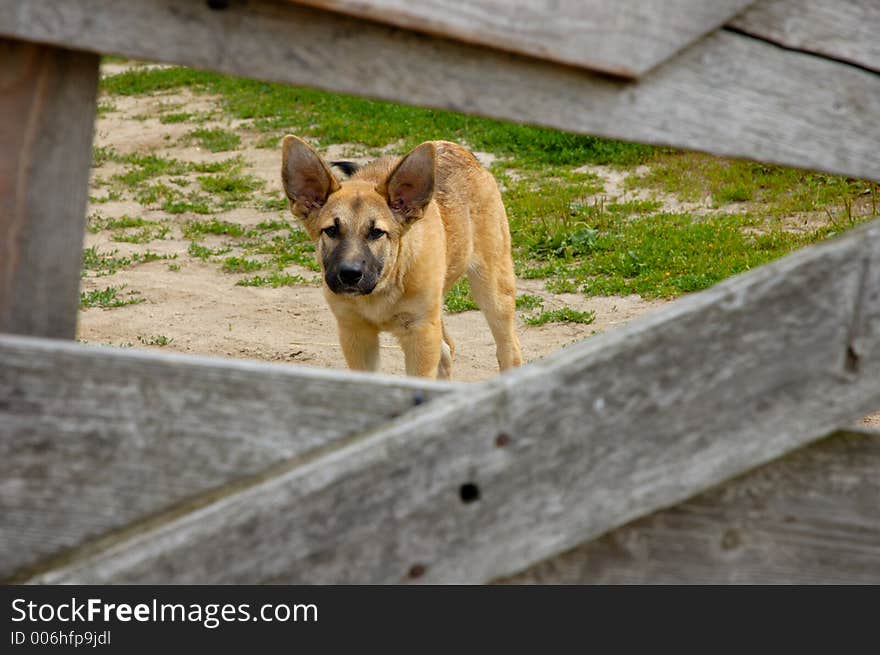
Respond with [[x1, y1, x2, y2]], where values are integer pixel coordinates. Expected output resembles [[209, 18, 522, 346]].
[[78, 66, 880, 427]]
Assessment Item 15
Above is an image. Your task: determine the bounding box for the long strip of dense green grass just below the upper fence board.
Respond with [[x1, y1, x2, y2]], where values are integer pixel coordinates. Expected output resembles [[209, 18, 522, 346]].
[[101, 67, 656, 168]]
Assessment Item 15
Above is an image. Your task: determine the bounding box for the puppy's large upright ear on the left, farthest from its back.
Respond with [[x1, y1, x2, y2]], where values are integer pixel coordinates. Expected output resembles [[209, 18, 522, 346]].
[[281, 134, 339, 220]]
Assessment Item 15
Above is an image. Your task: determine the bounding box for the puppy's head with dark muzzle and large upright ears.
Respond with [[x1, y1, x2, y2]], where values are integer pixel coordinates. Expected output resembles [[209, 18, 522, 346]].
[[281, 136, 436, 295]]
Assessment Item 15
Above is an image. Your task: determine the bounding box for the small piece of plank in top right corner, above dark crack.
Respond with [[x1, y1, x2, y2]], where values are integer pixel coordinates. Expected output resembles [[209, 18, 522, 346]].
[[729, 0, 880, 72]]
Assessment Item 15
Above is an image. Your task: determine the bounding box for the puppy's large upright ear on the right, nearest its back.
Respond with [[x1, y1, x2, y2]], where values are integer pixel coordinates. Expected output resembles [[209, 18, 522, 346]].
[[378, 142, 437, 223]]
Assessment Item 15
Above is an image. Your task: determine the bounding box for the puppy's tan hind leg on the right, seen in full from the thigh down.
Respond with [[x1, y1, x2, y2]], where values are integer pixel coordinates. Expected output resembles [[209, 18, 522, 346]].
[[468, 258, 522, 371]]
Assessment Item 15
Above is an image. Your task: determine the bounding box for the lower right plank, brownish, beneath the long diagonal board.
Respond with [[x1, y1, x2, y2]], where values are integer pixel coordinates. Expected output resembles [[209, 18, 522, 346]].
[[499, 432, 880, 584]]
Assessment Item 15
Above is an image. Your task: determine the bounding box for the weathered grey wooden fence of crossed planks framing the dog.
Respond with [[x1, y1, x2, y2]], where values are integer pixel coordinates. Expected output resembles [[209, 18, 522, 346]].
[[0, 0, 880, 583]]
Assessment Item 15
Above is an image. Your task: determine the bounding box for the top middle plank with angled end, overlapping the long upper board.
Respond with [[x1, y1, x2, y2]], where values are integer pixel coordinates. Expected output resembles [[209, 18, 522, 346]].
[[295, 0, 754, 77]]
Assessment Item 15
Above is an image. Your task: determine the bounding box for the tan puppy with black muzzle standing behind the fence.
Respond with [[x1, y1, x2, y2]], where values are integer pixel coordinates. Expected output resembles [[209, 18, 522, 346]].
[[281, 136, 522, 378]]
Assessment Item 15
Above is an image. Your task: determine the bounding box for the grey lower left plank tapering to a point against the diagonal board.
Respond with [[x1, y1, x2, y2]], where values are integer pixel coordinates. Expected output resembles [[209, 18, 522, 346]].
[[0, 335, 454, 577]]
